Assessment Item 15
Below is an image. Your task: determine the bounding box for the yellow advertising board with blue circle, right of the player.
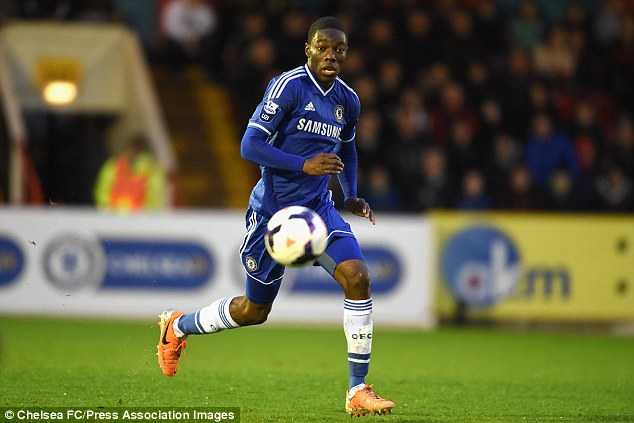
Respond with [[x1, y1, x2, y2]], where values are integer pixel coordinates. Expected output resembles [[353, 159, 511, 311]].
[[432, 213, 634, 322]]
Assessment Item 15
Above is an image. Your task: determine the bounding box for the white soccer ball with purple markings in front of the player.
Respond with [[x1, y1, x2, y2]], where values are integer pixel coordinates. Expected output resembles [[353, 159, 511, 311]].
[[264, 206, 328, 266]]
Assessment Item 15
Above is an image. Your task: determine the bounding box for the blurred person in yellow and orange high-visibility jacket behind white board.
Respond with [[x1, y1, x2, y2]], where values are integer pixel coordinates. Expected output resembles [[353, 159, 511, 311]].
[[95, 135, 167, 212]]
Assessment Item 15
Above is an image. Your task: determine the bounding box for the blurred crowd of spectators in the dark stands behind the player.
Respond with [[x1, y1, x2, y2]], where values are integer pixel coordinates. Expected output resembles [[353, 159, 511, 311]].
[[2, 0, 634, 212]]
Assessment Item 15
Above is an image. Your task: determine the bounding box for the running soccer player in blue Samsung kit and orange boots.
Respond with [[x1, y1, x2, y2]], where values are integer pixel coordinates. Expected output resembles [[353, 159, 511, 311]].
[[157, 17, 394, 415]]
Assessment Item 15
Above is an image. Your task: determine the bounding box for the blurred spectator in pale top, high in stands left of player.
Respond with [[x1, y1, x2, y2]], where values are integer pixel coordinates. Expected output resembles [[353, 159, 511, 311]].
[[161, 0, 218, 70]]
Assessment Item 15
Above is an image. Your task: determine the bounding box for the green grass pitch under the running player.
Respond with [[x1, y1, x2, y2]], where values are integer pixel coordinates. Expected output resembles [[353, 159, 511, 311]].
[[0, 316, 634, 423]]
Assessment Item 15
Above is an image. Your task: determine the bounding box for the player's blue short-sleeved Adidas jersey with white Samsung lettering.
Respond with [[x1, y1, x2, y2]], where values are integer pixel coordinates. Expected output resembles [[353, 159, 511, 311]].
[[248, 65, 361, 215]]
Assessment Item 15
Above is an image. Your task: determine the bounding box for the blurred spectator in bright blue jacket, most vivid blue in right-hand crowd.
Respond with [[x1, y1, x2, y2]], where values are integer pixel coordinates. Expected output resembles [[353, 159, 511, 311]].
[[525, 114, 579, 186]]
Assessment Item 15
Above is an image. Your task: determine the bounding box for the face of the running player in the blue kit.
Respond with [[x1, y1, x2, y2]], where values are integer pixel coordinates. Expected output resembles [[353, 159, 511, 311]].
[[305, 29, 348, 83]]
